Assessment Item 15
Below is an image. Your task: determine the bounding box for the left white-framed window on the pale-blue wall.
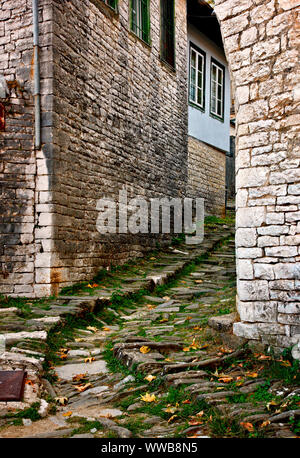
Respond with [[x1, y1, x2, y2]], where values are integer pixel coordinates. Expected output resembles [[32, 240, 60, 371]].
[[189, 43, 205, 110]]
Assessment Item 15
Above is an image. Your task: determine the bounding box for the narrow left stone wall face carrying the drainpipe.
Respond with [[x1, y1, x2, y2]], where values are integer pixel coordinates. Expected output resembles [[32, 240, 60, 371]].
[[0, 0, 51, 296]]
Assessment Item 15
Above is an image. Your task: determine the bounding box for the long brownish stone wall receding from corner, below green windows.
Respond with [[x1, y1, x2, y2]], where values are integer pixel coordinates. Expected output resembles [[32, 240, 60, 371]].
[[49, 0, 187, 287]]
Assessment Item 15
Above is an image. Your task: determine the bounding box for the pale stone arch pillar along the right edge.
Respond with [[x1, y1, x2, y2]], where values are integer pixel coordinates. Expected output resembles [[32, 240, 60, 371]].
[[215, 0, 300, 348]]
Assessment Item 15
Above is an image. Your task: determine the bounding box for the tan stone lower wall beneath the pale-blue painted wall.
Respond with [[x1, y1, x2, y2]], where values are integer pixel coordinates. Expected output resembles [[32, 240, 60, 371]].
[[187, 136, 226, 216]]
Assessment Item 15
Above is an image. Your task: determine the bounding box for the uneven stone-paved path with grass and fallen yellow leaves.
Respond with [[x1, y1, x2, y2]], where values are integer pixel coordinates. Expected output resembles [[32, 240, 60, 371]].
[[0, 218, 300, 438]]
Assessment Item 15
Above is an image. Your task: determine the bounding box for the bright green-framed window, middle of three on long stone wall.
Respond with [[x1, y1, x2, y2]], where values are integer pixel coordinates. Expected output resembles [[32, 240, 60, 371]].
[[130, 0, 150, 43]]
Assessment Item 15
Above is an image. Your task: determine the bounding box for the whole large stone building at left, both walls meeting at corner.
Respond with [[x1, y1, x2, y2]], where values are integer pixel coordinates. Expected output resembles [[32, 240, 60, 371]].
[[0, 0, 187, 297]]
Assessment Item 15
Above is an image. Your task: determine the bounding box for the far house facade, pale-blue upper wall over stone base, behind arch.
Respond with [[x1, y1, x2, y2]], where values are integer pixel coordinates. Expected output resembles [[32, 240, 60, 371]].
[[187, 0, 231, 215]]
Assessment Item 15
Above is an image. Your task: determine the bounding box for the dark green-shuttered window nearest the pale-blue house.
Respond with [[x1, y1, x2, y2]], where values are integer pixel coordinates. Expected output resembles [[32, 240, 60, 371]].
[[160, 0, 175, 68]]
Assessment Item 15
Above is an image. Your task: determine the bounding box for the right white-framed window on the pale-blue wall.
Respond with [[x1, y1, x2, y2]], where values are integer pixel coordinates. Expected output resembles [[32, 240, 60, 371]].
[[210, 59, 225, 120]]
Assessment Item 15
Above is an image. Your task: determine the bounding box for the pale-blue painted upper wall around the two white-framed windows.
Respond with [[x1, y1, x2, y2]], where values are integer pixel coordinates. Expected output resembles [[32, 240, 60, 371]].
[[188, 24, 231, 151]]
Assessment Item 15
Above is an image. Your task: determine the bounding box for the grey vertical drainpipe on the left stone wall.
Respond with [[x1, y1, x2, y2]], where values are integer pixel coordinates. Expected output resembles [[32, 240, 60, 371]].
[[32, 0, 41, 150]]
